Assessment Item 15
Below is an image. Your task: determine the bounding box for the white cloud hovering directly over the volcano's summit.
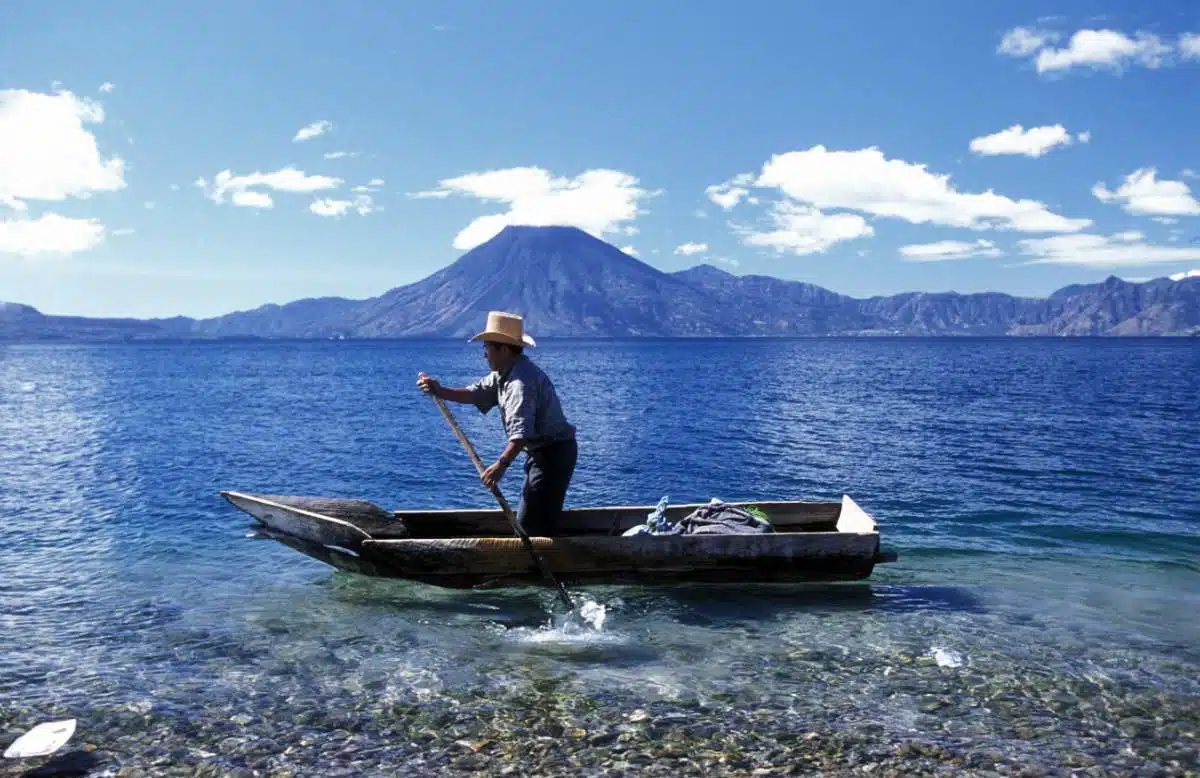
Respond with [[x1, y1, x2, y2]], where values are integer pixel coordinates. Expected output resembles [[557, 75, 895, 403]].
[[412, 167, 656, 250]]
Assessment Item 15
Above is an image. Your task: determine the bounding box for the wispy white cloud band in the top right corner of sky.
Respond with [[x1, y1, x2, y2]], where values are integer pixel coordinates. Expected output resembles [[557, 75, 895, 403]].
[[997, 28, 1200, 73]]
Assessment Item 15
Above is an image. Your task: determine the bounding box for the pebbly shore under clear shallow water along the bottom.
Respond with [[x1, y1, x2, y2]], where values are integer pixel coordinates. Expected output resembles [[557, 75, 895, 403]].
[[0, 652, 1200, 778]]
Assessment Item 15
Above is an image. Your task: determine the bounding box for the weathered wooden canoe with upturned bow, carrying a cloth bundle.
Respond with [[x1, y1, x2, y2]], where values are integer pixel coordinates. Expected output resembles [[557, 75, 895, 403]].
[[221, 491, 896, 588]]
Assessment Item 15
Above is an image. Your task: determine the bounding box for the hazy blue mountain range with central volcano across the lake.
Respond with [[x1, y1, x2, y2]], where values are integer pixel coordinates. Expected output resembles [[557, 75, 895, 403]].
[[0, 227, 1200, 341]]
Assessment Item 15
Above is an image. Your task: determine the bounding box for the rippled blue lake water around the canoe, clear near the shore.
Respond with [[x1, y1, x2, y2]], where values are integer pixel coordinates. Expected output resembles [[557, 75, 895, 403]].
[[0, 340, 1200, 774]]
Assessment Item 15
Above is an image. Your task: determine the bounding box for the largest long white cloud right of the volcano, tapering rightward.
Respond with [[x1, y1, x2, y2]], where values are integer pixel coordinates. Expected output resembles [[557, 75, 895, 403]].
[[708, 145, 1092, 246]]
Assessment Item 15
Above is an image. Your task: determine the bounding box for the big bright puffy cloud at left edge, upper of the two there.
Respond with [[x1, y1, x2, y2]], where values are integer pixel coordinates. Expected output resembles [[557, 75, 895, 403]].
[[0, 89, 125, 210]]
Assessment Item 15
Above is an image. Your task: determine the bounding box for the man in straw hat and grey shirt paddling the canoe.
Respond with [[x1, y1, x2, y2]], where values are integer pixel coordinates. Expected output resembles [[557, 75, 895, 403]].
[[416, 311, 577, 537]]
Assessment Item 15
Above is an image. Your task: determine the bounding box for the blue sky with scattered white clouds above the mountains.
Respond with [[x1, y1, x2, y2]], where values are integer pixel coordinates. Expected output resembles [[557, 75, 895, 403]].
[[0, 0, 1200, 317]]
